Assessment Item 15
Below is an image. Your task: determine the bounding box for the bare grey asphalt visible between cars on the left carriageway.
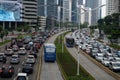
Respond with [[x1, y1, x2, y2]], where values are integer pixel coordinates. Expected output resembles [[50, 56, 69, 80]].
[[0, 46, 40, 80]]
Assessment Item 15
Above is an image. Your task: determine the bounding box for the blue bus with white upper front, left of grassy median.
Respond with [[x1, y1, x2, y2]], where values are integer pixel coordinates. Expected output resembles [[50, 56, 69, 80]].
[[44, 43, 56, 62]]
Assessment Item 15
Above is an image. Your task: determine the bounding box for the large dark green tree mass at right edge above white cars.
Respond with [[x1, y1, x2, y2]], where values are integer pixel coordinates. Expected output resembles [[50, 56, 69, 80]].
[[98, 13, 120, 42]]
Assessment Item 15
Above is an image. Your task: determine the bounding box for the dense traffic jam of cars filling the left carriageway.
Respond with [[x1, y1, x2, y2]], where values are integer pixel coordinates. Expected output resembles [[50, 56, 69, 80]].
[[0, 31, 55, 80]]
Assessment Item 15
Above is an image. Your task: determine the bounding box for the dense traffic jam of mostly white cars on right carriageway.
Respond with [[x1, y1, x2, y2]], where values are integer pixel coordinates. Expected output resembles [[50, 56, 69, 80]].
[[72, 29, 120, 73]]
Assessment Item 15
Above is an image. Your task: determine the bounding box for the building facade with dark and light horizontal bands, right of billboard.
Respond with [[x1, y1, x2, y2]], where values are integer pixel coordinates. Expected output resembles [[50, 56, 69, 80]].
[[21, 0, 37, 27]]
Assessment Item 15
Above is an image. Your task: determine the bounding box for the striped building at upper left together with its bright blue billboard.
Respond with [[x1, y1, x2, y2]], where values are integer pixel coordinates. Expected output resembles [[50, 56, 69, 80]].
[[0, 0, 37, 27]]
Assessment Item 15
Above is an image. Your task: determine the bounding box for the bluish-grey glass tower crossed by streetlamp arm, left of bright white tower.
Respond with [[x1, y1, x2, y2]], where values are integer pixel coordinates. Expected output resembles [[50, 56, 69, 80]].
[[85, 0, 101, 25]]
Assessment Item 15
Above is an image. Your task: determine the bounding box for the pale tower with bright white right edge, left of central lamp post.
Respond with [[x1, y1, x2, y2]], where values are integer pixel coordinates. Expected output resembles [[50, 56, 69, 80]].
[[63, 0, 72, 22]]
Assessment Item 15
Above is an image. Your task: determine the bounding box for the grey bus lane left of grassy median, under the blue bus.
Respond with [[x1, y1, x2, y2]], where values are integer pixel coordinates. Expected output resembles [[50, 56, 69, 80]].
[[40, 33, 63, 80]]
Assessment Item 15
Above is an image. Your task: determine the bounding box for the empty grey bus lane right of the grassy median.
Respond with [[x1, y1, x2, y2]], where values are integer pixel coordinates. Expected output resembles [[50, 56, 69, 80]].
[[67, 33, 116, 80]]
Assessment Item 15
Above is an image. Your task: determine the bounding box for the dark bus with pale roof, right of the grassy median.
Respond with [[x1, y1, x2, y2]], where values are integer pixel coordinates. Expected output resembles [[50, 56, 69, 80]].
[[65, 35, 75, 47]]
